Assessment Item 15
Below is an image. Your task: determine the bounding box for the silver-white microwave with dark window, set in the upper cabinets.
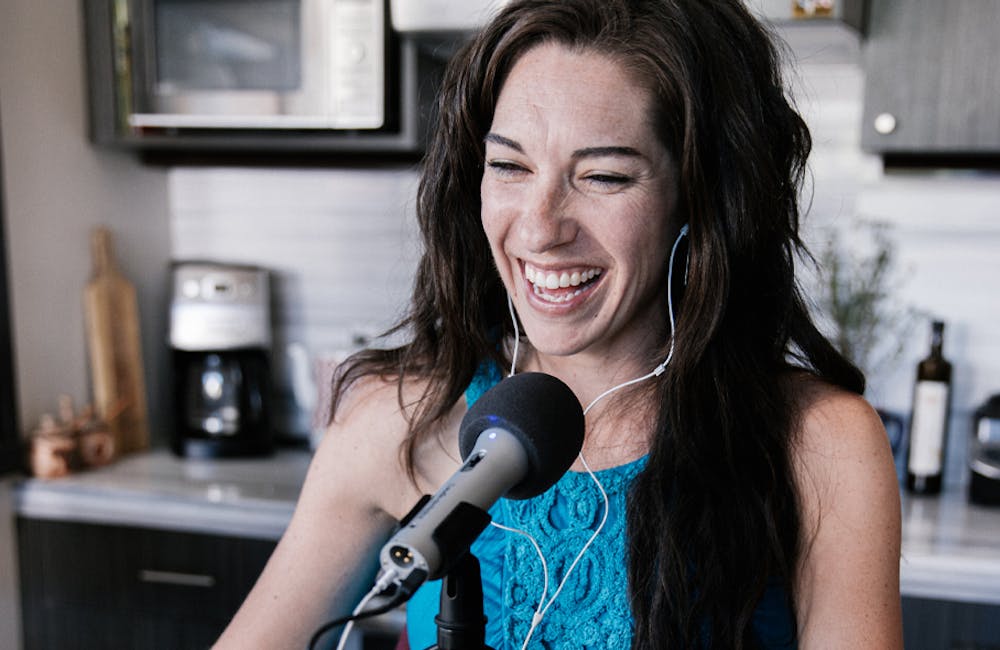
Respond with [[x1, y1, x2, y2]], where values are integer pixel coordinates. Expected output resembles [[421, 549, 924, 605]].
[[128, 0, 386, 129]]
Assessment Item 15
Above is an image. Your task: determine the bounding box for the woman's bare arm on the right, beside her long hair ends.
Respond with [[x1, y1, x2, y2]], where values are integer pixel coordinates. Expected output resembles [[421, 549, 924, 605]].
[[795, 388, 903, 650]]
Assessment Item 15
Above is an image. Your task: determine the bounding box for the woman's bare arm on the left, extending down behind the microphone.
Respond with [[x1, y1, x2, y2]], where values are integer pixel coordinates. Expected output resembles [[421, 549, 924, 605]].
[[216, 379, 446, 650]]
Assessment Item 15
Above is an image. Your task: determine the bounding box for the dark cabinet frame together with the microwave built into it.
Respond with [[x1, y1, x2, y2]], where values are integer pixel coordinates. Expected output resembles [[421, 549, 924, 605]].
[[84, 0, 443, 151]]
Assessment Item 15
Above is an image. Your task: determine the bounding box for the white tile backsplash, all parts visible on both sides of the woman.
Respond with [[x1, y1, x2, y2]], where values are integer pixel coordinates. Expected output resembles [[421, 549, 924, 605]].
[[170, 63, 1000, 482]]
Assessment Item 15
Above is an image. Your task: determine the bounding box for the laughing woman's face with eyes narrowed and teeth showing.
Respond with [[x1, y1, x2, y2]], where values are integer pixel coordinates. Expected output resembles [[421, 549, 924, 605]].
[[481, 44, 680, 368]]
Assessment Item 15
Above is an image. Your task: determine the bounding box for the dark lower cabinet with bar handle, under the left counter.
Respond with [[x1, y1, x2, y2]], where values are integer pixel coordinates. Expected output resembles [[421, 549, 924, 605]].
[[17, 517, 275, 650]]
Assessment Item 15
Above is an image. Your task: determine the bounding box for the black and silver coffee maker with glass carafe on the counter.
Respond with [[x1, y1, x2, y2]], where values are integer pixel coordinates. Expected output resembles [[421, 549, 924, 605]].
[[170, 262, 274, 458]]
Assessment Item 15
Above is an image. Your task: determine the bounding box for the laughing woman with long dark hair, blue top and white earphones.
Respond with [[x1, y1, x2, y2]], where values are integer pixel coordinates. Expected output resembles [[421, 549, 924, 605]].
[[220, 0, 902, 649]]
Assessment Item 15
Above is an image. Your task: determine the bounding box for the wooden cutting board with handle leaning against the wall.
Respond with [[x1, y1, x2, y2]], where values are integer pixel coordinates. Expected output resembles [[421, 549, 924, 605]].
[[83, 227, 149, 454]]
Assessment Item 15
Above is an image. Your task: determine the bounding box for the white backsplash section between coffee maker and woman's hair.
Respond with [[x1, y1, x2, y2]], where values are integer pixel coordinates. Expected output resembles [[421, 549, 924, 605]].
[[170, 168, 418, 351]]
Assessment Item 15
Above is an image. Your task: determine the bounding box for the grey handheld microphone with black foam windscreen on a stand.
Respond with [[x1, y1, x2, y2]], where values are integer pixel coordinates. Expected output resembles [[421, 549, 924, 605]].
[[379, 372, 584, 589]]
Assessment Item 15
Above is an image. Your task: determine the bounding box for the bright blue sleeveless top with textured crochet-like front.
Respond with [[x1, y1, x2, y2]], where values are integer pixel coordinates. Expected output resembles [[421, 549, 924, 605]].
[[406, 364, 797, 650]]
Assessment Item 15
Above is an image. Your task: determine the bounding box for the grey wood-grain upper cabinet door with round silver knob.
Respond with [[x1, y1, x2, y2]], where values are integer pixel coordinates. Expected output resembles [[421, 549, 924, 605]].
[[861, 0, 1000, 156]]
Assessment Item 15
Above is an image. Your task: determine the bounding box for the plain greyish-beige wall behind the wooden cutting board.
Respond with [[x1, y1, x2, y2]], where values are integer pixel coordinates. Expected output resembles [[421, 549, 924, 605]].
[[0, 0, 170, 648]]
